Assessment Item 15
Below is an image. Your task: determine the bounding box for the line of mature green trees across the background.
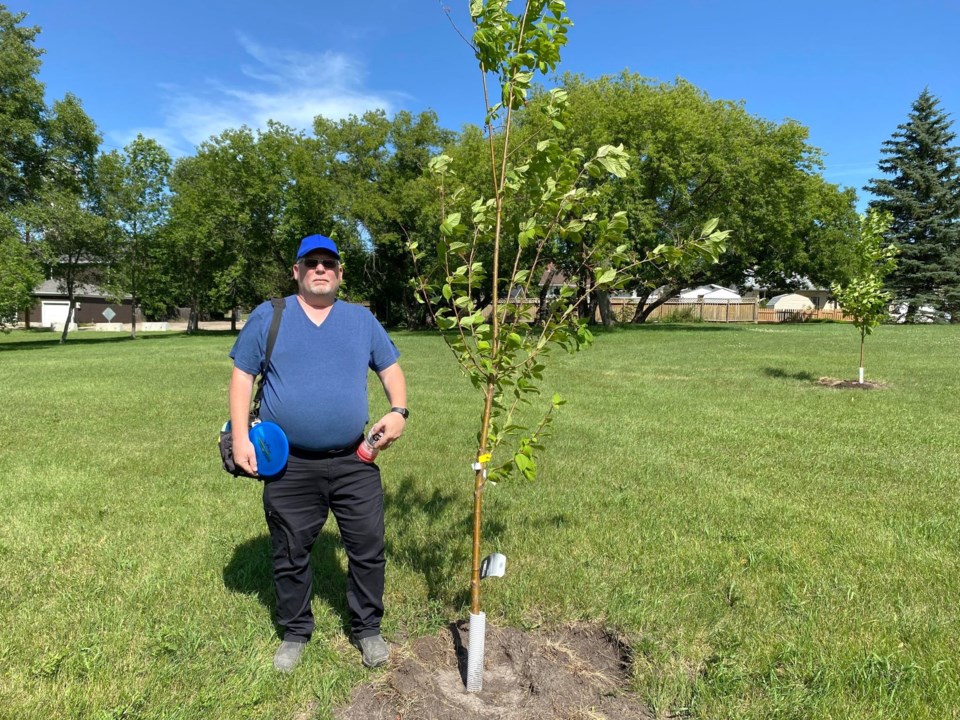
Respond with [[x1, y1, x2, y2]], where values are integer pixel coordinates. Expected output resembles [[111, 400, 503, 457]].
[[0, 5, 960, 333]]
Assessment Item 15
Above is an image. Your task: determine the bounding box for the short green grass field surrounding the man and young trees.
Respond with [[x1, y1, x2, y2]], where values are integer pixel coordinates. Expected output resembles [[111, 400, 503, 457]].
[[0, 325, 960, 720]]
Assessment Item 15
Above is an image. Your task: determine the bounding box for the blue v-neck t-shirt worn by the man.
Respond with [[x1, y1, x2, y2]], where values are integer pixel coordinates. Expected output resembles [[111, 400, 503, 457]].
[[230, 295, 400, 451]]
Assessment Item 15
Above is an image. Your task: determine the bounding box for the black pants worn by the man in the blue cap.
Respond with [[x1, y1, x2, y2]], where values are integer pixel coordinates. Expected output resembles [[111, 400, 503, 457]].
[[263, 448, 386, 641]]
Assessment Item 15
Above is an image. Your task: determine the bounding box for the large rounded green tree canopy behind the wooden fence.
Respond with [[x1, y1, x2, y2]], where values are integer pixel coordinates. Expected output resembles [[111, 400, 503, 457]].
[[512, 73, 857, 320]]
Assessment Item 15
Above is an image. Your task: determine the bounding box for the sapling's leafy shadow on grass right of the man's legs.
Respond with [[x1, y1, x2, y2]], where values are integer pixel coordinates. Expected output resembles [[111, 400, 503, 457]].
[[386, 475, 506, 607]]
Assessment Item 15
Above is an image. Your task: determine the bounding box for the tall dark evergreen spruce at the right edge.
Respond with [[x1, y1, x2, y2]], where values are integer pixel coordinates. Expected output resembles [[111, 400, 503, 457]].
[[864, 89, 960, 322]]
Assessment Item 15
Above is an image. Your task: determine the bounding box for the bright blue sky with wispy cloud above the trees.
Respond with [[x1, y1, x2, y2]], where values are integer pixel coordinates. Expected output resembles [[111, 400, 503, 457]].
[[5, 0, 960, 208]]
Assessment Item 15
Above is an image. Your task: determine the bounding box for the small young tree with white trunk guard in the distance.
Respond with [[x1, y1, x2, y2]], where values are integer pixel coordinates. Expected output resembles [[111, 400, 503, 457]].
[[830, 209, 897, 385]]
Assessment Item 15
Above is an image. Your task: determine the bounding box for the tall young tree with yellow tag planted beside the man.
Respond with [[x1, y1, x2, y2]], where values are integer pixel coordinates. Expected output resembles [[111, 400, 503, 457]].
[[409, 0, 725, 691]]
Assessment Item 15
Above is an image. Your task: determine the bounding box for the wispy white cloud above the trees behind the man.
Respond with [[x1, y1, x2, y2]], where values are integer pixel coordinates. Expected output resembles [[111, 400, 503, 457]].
[[110, 35, 402, 155]]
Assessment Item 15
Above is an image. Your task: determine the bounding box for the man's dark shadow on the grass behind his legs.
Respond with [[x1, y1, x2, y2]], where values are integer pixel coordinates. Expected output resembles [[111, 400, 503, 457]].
[[223, 527, 350, 638]]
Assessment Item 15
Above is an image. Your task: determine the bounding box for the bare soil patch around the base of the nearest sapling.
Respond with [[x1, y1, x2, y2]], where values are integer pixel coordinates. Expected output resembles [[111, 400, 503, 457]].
[[334, 621, 653, 720]]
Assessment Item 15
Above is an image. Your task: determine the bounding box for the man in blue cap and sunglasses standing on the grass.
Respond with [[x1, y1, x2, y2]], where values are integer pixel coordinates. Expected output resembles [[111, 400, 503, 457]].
[[230, 235, 409, 672]]
